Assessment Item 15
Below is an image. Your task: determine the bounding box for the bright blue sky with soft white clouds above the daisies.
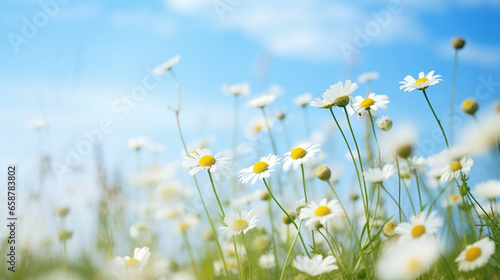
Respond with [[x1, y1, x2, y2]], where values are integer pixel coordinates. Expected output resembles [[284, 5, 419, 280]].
[[0, 0, 500, 185]]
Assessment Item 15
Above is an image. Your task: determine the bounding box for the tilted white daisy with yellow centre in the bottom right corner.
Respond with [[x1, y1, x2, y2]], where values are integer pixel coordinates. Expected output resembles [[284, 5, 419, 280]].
[[455, 237, 495, 271]]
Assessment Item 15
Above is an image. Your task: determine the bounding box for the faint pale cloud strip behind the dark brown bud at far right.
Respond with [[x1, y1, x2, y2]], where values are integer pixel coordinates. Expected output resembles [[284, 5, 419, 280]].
[[436, 40, 500, 67]]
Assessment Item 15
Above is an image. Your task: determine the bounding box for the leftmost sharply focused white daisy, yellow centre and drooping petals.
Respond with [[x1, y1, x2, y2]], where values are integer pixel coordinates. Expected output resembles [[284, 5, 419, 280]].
[[182, 149, 229, 180]]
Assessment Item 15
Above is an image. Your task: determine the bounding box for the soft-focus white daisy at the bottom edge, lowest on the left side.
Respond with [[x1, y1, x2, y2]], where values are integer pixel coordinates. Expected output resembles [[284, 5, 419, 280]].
[[113, 247, 151, 279]]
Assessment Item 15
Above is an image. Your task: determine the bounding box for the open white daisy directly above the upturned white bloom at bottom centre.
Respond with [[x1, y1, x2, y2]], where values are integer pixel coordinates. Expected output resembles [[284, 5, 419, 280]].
[[299, 198, 342, 229]]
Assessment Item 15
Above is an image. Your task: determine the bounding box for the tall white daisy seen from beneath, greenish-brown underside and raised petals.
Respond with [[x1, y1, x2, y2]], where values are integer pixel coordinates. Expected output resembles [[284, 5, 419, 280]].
[[310, 80, 358, 109]]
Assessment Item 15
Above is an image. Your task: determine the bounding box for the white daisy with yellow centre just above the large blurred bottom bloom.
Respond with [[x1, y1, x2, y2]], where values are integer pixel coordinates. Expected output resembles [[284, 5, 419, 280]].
[[394, 211, 443, 240]]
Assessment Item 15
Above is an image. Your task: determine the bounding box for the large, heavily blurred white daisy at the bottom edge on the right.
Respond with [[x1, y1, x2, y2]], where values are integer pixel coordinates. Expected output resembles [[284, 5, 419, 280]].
[[377, 239, 439, 280]]
